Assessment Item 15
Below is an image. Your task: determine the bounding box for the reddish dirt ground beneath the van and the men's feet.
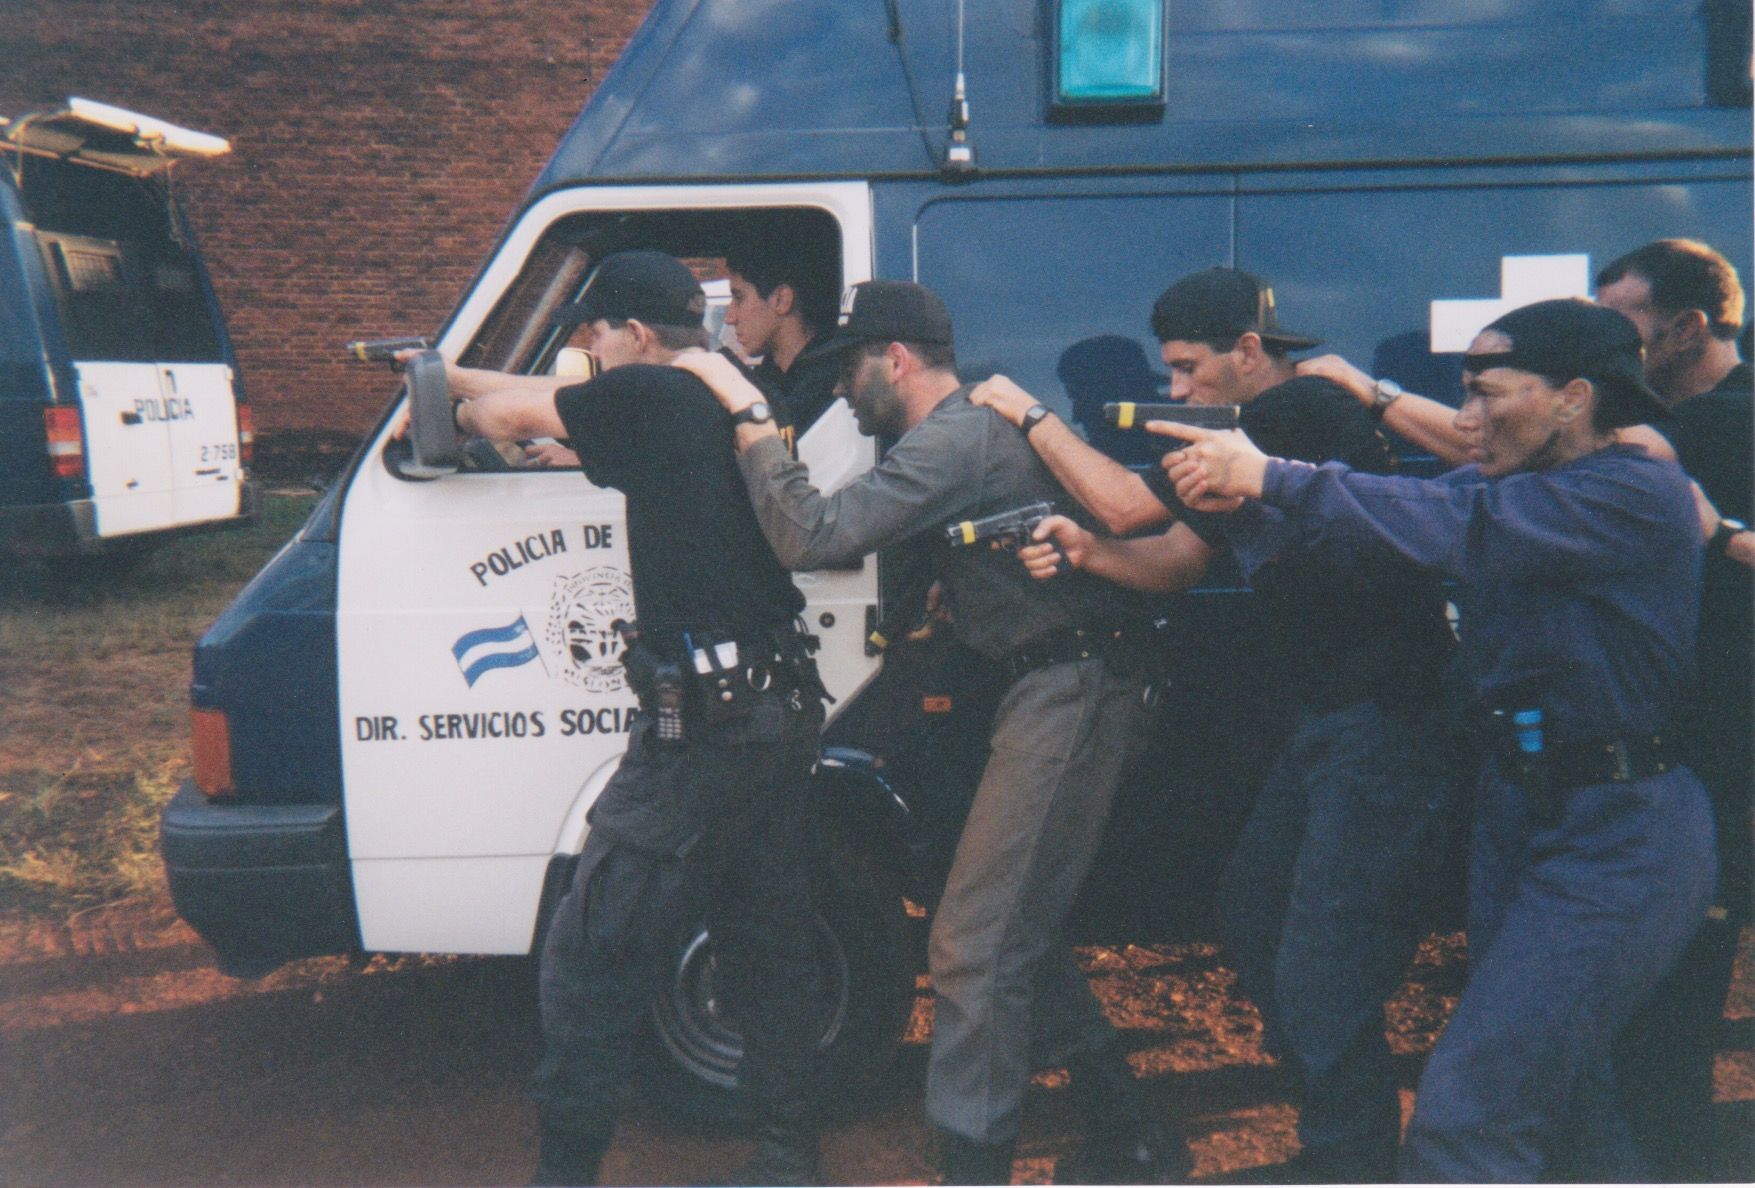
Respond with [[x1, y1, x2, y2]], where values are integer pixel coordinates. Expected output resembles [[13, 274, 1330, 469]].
[[0, 902, 1755, 1188]]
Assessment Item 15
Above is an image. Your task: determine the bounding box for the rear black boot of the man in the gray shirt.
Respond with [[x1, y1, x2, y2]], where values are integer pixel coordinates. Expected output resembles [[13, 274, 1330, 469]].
[[1055, 1044, 1195, 1184]]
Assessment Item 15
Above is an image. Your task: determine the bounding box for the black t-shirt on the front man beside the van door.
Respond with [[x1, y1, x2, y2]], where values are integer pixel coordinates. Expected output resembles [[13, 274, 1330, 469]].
[[555, 363, 804, 646]]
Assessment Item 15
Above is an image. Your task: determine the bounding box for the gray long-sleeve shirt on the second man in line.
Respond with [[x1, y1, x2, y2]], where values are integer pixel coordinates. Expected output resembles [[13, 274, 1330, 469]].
[[739, 386, 1130, 658]]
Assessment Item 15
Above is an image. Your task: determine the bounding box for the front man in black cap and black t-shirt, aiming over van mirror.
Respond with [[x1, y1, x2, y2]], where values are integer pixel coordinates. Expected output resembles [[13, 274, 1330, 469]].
[[442, 251, 823, 1184]]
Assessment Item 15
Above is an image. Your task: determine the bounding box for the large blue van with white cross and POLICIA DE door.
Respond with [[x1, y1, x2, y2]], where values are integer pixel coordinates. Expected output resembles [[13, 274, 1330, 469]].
[[163, 0, 1751, 1097]]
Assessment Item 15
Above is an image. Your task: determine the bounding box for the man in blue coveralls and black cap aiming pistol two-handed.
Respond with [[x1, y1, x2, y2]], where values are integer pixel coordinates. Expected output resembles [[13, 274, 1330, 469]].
[[1164, 300, 1716, 1183]]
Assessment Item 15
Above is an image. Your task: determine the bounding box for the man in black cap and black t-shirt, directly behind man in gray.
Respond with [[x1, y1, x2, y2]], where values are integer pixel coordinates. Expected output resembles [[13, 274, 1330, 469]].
[[974, 268, 1458, 1183]]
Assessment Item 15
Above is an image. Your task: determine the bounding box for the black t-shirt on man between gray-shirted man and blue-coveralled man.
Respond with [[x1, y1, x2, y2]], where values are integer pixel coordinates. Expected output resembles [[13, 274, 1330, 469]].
[[1144, 376, 1453, 711]]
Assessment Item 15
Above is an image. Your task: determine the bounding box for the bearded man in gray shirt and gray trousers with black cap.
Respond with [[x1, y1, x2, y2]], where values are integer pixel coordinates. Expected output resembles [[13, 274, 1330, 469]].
[[679, 281, 1192, 1184]]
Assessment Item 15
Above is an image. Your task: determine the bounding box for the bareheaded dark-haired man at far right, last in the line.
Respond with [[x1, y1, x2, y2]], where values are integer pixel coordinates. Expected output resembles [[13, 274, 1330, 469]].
[[1597, 239, 1755, 1179]]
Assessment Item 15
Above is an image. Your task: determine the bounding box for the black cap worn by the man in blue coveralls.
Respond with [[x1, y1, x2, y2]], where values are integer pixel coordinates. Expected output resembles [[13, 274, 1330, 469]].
[[1462, 297, 1669, 428]]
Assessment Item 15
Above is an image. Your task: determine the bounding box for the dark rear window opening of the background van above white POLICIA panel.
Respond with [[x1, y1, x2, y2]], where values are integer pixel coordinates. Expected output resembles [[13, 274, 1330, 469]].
[[21, 158, 225, 363]]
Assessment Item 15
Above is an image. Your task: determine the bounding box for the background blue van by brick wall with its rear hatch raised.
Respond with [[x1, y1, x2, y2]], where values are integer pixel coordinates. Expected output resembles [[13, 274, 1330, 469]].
[[0, 98, 256, 569]]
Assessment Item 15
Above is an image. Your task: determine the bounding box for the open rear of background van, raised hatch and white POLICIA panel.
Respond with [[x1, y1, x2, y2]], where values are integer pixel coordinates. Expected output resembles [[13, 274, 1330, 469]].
[[0, 98, 253, 551]]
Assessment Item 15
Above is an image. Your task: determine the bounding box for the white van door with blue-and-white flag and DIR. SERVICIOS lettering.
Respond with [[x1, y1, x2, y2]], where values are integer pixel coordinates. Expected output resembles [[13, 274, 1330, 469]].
[[335, 184, 876, 953]]
